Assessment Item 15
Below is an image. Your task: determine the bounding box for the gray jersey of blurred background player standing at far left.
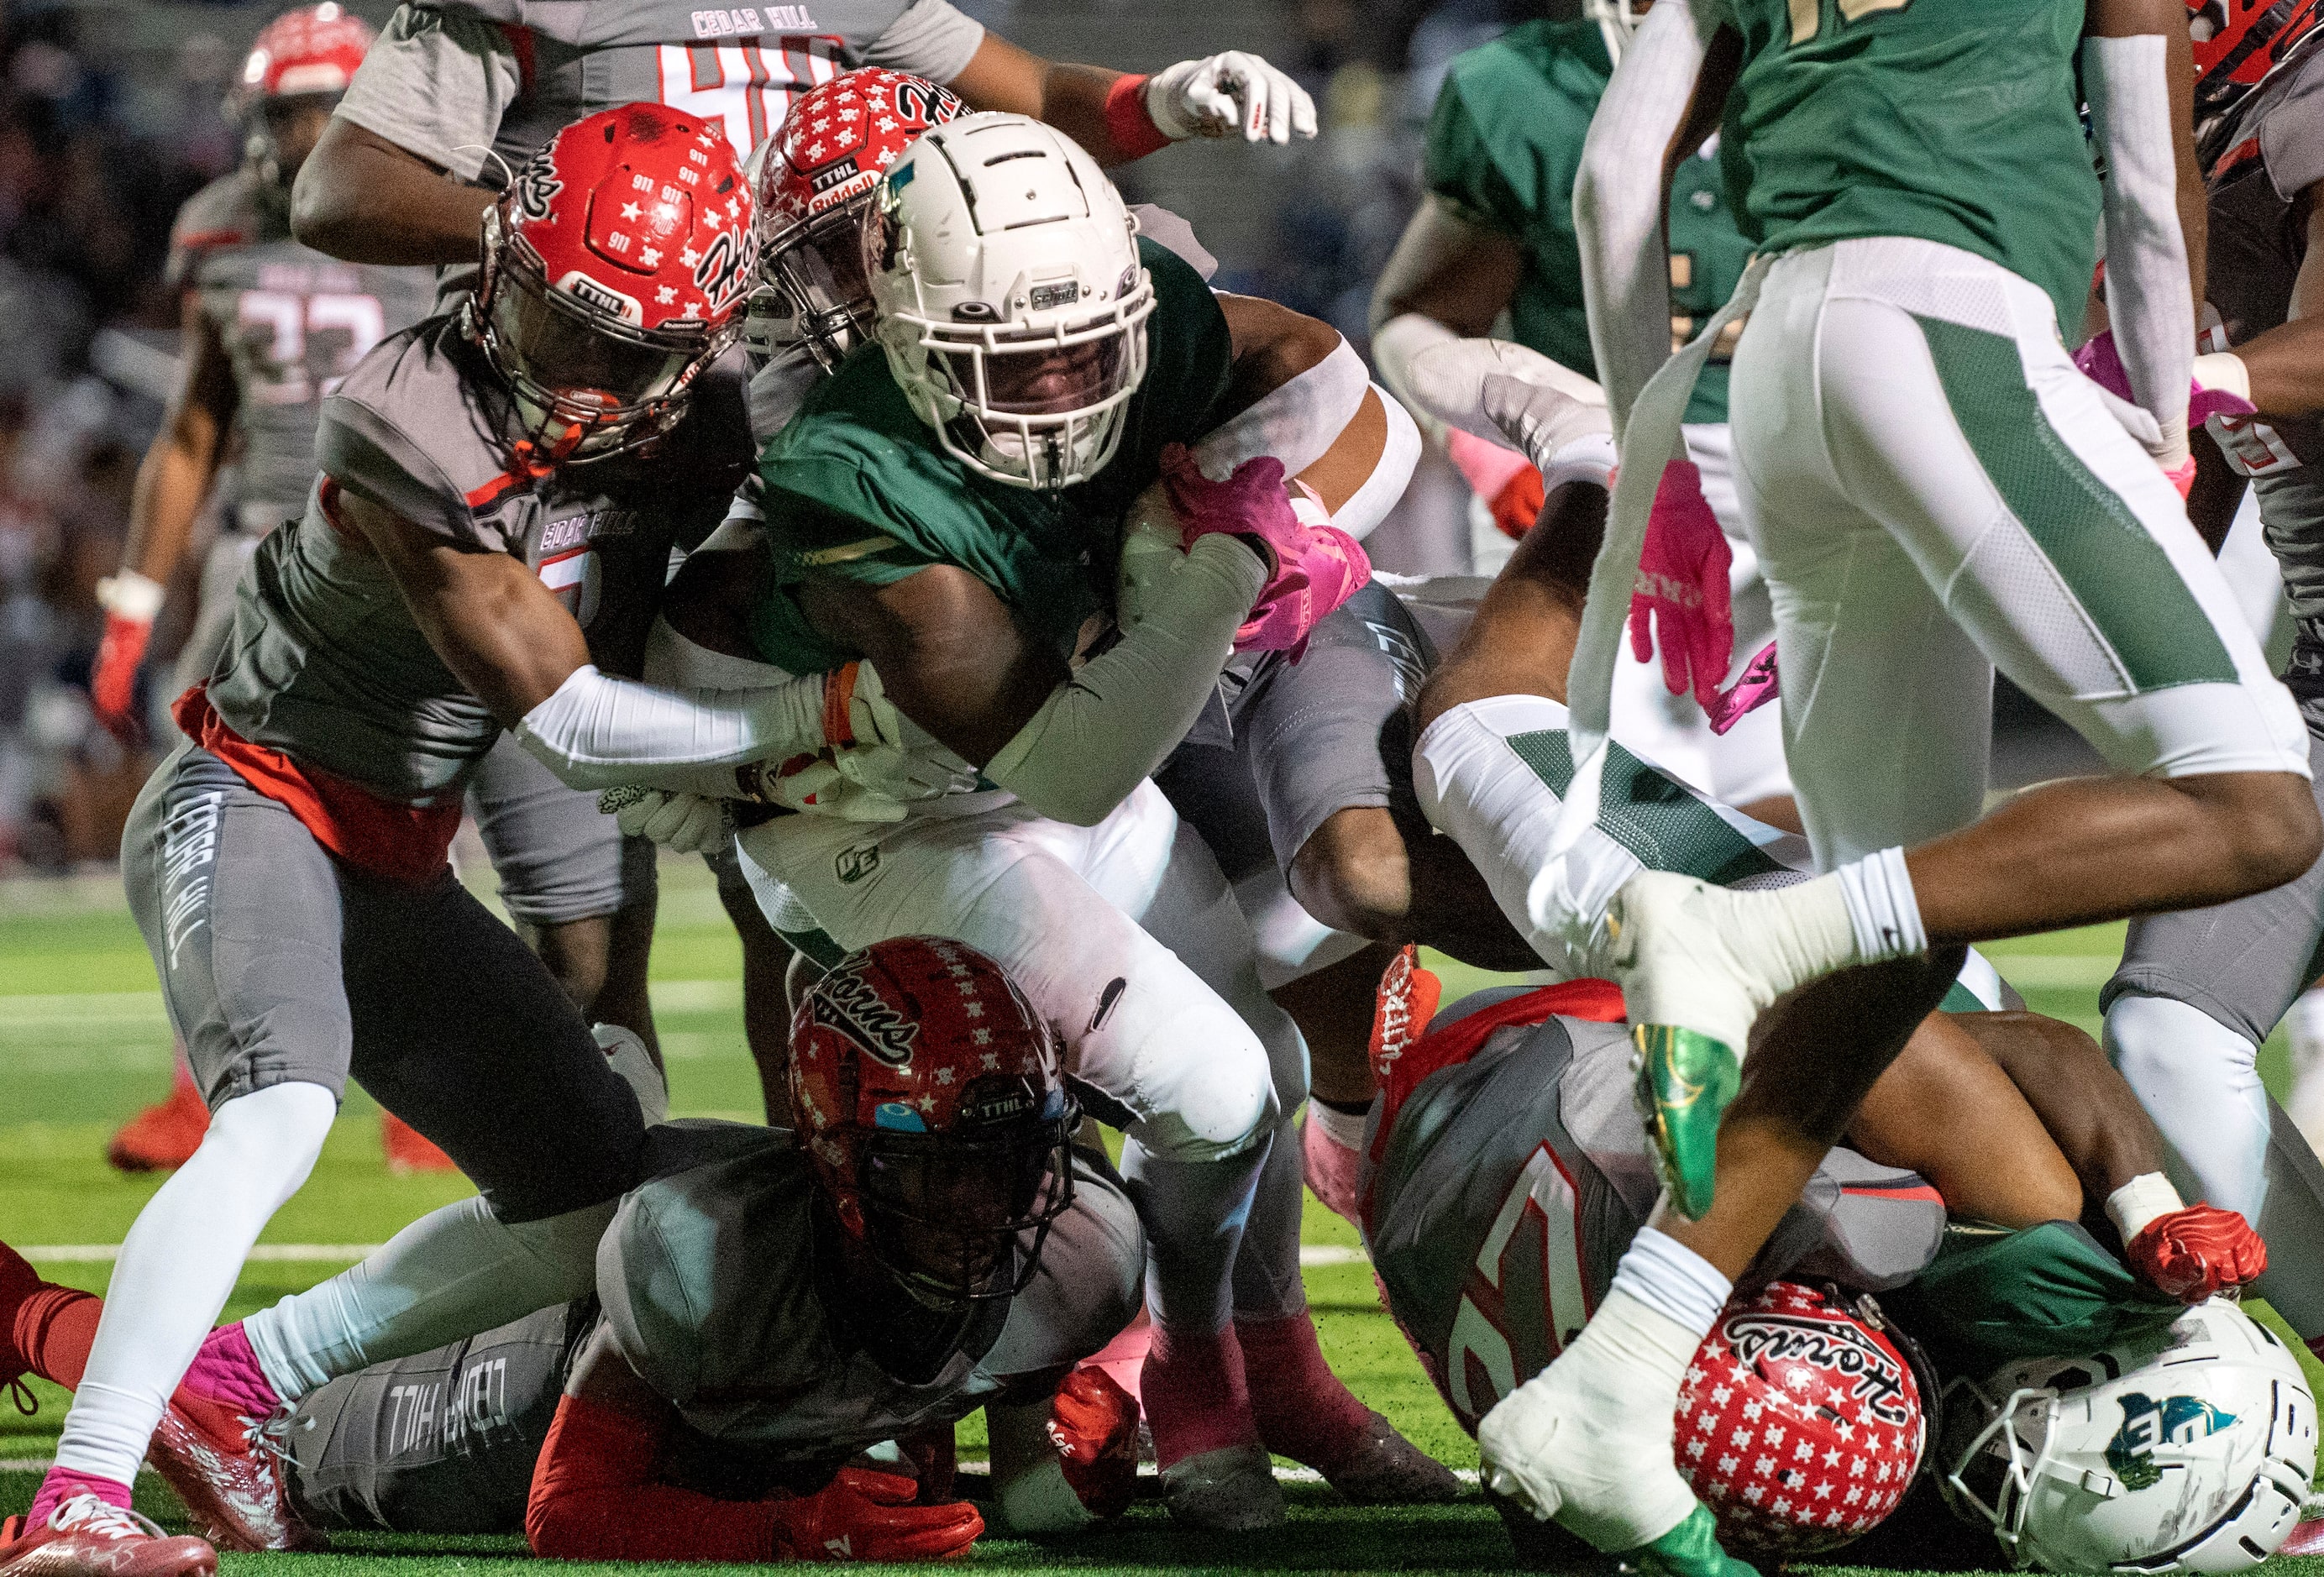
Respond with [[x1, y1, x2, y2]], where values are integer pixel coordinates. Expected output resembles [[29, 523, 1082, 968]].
[[165, 170, 434, 532]]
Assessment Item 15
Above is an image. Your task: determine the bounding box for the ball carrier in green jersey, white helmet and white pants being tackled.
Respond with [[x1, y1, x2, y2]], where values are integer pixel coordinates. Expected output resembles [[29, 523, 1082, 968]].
[[608, 116, 1448, 1526]]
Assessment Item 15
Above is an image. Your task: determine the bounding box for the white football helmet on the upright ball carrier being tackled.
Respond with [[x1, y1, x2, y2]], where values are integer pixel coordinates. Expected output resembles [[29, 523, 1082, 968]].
[[864, 114, 1155, 492]]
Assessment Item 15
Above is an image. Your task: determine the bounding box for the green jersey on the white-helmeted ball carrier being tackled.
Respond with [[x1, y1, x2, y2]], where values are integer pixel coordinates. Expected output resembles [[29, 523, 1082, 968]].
[[751, 239, 1234, 673]]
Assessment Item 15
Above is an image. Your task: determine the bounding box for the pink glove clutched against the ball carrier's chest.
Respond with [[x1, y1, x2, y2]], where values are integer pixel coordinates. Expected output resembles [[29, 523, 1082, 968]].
[[1162, 443, 1372, 662]]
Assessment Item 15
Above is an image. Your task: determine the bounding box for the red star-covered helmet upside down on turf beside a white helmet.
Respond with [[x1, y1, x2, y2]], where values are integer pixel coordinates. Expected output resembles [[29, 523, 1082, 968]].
[[1676, 1282, 1924, 1556]]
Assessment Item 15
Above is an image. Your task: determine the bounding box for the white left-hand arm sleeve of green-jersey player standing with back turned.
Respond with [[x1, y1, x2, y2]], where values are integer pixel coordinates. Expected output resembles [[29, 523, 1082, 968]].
[[1573, 0, 1718, 437]]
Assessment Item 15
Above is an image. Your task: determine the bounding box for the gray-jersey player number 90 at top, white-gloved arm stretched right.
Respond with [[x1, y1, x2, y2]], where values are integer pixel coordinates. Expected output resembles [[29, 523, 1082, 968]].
[[293, 0, 1315, 276]]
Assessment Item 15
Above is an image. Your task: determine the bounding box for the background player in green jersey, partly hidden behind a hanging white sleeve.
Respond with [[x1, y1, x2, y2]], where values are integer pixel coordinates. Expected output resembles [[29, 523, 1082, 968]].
[[1372, 0, 1799, 831]]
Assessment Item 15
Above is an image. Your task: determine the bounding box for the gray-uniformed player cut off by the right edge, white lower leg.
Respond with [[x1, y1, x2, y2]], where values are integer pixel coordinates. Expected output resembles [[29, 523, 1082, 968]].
[[2101, 7, 2324, 1393]]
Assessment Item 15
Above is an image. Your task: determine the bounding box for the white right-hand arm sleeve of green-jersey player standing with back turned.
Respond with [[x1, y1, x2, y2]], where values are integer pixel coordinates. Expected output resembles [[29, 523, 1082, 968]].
[[2082, 33, 2194, 469]]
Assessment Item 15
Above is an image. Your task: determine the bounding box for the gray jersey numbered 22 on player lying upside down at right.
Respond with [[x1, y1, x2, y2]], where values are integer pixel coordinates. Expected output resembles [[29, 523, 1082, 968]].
[[1361, 992, 1945, 1433]]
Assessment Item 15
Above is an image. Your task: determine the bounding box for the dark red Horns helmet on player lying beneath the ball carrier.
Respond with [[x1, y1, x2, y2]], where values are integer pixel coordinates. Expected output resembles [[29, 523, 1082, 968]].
[[788, 936, 1081, 1305]]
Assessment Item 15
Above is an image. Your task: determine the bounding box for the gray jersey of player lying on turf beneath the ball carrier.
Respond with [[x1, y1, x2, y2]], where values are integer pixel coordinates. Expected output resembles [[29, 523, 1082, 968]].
[[597, 1122, 1146, 1480]]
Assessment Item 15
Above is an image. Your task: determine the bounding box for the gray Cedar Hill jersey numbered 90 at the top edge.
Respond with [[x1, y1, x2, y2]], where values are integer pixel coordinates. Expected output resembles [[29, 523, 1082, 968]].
[[337, 0, 985, 184]]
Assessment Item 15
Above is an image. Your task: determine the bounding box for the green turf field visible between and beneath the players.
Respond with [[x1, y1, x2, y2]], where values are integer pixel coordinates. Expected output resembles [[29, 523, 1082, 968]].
[[0, 862, 2324, 1577]]
